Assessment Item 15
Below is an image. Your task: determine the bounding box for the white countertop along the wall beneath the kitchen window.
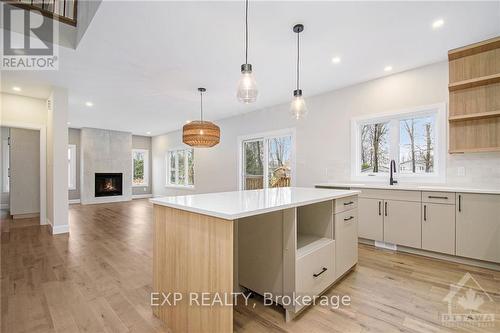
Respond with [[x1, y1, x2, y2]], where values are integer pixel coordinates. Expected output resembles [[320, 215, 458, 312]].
[[316, 182, 500, 194]]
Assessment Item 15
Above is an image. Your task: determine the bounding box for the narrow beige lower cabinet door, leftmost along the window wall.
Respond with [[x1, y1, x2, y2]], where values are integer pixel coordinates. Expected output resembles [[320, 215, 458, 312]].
[[358, 198, 384, 241]]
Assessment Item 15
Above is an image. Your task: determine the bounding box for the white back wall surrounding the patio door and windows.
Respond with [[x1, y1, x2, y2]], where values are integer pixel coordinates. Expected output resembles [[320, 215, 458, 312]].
[[153, 62, 500, 195]]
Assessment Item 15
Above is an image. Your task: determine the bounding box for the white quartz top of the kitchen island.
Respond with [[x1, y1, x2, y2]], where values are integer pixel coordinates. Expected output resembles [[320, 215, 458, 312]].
[[150, 187, 360, 220]]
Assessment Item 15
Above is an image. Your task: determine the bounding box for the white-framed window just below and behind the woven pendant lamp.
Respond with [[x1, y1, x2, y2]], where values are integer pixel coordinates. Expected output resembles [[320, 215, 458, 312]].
[[167, 148, 194, 187]]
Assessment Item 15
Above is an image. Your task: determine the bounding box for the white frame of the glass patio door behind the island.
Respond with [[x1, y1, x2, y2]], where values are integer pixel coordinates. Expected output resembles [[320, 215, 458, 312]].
[[237, 128, 296, 191]]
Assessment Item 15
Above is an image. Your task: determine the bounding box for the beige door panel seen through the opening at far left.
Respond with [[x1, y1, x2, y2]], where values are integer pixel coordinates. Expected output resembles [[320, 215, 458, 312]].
[[10, 128, 40, 216]]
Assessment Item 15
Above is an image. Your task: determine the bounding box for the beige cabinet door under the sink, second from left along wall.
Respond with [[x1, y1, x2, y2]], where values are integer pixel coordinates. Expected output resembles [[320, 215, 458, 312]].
[[384, 200, 422, 248]]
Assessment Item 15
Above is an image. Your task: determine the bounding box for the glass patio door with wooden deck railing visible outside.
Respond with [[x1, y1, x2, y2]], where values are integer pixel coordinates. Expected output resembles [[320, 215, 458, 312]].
[[240, 130, 294, 190]]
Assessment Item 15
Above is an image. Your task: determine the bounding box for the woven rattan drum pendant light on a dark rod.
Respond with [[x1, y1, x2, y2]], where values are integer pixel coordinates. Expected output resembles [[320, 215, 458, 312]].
[[182, 88, 220, 148]]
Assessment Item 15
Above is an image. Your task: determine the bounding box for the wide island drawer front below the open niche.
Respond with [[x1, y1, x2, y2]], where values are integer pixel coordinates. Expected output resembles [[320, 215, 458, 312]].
[[296, 240, 335, 300]]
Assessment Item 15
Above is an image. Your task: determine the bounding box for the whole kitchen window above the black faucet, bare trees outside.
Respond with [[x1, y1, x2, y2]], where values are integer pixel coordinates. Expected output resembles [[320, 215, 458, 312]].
[[351, 105, 446, 181]]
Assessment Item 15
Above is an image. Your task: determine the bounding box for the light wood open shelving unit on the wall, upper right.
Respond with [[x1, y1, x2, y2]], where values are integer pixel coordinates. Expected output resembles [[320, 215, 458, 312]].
[[448, 37, 500, 153]]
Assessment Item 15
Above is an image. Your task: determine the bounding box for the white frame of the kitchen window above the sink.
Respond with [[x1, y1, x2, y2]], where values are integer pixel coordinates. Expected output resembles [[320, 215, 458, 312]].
[[351, 103, 448, 183]]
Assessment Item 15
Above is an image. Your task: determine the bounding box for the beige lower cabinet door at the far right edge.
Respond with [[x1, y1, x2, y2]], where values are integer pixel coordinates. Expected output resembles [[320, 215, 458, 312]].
[[456, 193, 500, 263]]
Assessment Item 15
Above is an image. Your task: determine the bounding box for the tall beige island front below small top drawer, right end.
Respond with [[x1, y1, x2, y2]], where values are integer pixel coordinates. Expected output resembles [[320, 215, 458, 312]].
[[335, 209, 358, 277]]
